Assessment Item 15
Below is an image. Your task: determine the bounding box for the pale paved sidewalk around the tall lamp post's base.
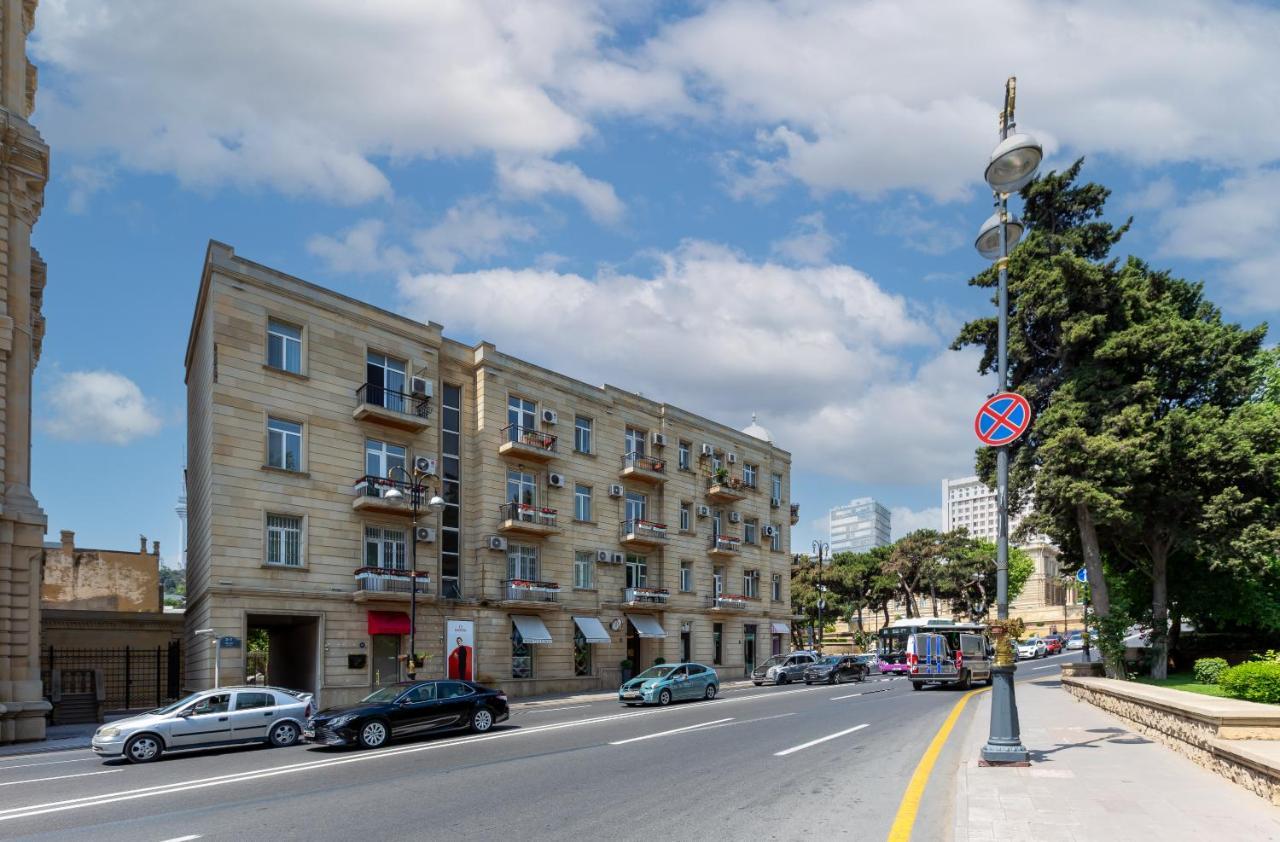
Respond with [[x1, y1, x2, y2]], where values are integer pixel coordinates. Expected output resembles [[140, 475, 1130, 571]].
[[954, 677, 1280, 842]]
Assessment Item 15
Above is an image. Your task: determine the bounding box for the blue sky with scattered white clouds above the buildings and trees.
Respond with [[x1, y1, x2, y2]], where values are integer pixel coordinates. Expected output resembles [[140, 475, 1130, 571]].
[[22, 0, 1280, 559]]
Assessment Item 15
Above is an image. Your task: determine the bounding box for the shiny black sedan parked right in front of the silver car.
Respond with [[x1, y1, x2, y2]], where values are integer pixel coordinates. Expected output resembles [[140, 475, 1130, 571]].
[[302, 679, 511, 749]]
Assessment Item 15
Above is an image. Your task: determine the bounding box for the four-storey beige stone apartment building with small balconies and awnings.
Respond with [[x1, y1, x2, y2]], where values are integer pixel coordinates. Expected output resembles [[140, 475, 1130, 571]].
[[186, 243, 797, 704]]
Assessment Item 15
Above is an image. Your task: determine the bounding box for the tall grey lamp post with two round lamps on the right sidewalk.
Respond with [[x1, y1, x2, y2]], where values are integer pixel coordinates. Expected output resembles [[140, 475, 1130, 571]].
[[975, 77, 1043, 765]]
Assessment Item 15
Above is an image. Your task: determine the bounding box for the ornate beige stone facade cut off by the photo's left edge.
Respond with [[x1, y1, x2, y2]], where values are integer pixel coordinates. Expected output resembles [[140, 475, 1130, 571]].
[[0, 0, 49, 743]]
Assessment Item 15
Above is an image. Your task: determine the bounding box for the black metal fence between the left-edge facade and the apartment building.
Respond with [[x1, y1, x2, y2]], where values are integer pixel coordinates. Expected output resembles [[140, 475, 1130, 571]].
[[40, 641, 182, 710]]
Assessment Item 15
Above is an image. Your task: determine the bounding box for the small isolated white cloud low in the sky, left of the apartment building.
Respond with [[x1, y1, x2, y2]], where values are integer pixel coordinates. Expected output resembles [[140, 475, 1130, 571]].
[[42, 371, 163, 444]]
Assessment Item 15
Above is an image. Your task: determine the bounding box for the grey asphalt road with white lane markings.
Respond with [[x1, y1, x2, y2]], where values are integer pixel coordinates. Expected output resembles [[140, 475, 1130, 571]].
[[0, 653, 1078, 842]]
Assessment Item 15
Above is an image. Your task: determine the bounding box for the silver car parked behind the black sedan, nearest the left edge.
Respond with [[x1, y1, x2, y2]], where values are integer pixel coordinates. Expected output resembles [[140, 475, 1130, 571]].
[[90, 686, 315, 763]]
